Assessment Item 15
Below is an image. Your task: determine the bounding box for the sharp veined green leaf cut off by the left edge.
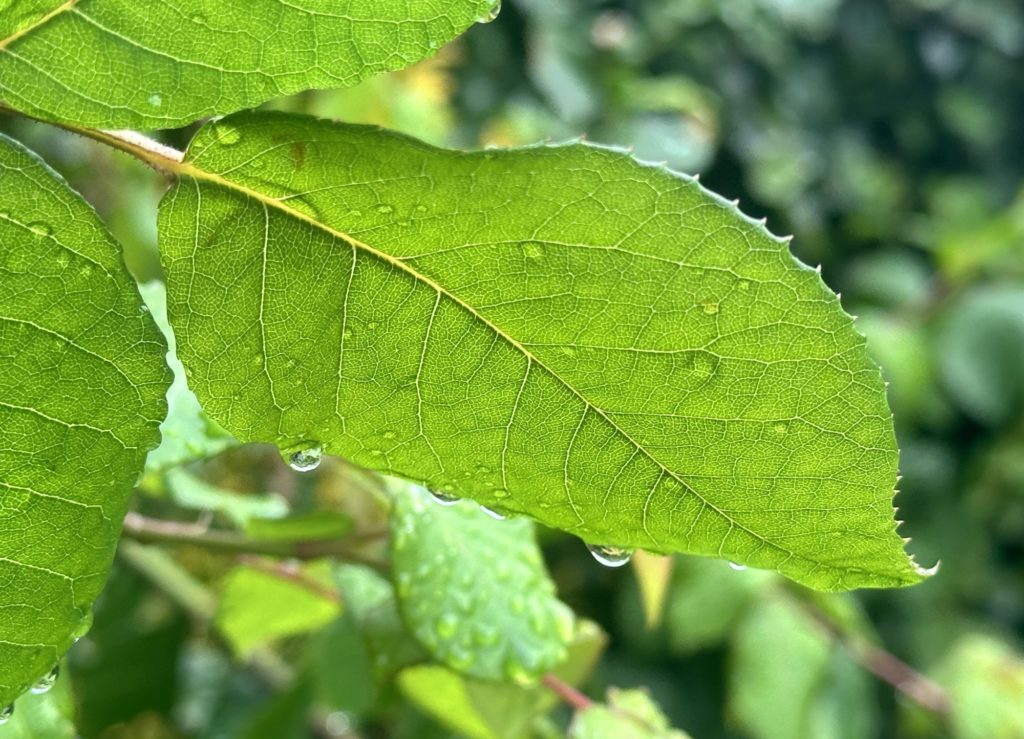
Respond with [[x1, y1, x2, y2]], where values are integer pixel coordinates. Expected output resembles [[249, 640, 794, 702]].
[[0, 136, 170, 706]]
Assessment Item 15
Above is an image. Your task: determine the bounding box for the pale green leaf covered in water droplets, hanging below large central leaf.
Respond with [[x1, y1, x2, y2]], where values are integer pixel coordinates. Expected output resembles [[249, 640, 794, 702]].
[[391, 485, 573, 683]]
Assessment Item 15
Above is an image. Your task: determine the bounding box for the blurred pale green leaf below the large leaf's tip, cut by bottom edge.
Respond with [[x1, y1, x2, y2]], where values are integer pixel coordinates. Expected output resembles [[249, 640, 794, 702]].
[[729, 597, 874, 739]]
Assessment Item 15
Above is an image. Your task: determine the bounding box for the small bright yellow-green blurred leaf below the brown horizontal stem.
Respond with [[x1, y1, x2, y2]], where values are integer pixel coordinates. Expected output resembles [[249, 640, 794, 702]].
[[215, 567, 341, 657]]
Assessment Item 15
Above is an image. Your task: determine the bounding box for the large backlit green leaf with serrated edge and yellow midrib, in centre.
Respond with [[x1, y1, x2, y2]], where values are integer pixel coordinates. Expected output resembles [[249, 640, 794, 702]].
[[159, 114, 924, 590]]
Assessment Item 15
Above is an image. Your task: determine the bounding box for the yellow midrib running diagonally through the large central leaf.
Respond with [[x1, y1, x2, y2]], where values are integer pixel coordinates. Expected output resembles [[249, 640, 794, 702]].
[[174, 156, 861, 573]]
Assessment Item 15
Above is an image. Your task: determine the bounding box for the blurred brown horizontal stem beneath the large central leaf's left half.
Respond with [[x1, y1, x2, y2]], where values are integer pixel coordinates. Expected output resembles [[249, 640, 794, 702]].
[[124, 512, 388, 572]]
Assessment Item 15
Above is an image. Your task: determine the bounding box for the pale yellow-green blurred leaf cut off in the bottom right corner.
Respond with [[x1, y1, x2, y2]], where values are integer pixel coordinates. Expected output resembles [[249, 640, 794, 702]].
[[937, 635, 1024, 739]]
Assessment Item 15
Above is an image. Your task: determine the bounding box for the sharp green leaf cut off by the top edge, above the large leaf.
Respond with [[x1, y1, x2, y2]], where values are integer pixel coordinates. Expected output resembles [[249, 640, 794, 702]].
[[0, 0, 497, 128]]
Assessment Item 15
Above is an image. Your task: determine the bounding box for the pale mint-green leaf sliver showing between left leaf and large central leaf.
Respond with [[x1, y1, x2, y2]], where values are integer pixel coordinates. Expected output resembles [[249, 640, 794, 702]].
[[139, 280, 238, 475]]
